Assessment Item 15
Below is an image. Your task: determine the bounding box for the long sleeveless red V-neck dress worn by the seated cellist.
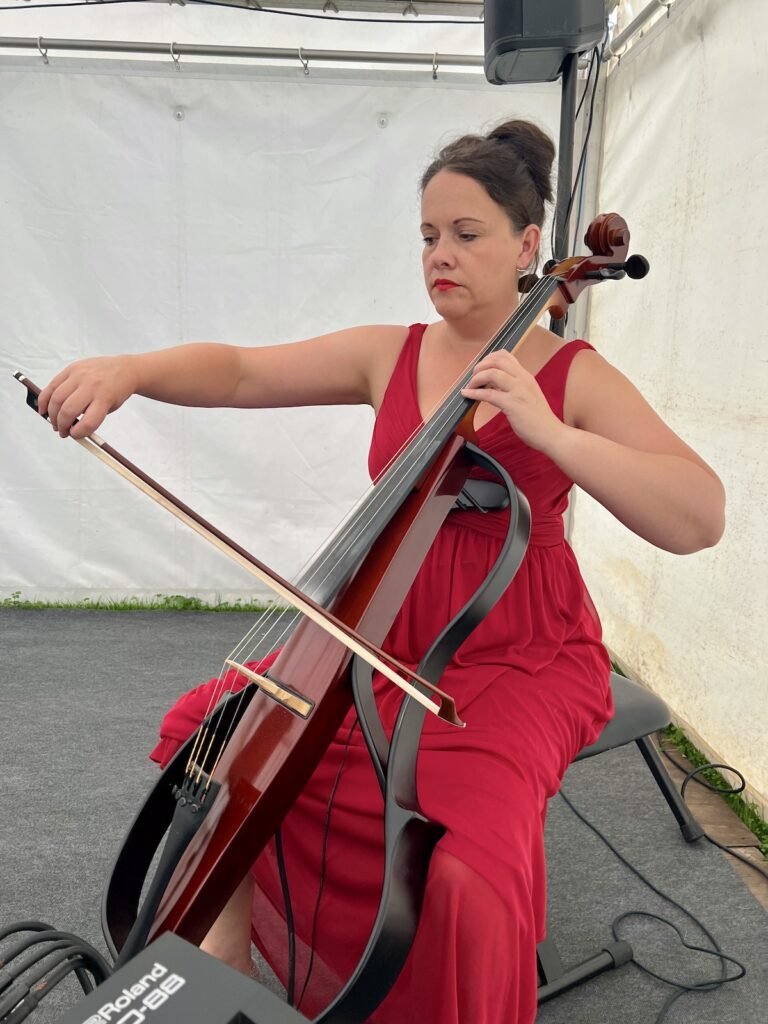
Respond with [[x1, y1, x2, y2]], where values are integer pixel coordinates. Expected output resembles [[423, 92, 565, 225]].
[[152, 325, 612, 1024]]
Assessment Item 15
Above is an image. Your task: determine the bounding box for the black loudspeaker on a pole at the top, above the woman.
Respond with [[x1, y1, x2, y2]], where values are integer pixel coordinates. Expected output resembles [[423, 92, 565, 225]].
[[485, 0, 605, 85]]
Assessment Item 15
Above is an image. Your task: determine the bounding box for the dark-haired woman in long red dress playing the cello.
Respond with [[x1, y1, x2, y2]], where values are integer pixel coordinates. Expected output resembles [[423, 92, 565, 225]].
[[39, 121, 724, 1024]]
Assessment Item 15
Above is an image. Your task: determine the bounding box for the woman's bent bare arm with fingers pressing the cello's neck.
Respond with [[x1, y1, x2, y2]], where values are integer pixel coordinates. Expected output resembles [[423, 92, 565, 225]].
[[464, 351, 725, 555]]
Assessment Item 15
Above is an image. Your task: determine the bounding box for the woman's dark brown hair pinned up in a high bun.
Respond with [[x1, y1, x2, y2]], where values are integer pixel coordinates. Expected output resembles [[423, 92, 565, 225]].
[[421, 120, 555, 240]]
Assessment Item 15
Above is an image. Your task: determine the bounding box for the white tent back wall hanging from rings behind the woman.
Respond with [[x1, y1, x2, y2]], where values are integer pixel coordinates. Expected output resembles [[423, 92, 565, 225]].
[[0, 57, 559, 600]]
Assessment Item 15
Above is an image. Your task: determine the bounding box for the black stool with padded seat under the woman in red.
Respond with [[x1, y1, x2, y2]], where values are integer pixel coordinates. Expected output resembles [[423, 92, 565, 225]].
[[537, 672, 703, 1005]]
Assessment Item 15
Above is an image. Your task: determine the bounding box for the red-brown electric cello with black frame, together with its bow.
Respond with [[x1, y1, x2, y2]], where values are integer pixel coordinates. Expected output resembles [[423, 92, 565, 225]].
[[6, 214, 648, 1024]]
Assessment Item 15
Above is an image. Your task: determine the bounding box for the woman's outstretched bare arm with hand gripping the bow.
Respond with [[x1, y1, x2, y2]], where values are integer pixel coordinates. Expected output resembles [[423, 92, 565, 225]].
[[38, 326, 406, 437]]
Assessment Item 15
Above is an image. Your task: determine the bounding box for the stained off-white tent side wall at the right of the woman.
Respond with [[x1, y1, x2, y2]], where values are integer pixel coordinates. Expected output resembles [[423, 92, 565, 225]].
[[572, 0, 768, 809]]
